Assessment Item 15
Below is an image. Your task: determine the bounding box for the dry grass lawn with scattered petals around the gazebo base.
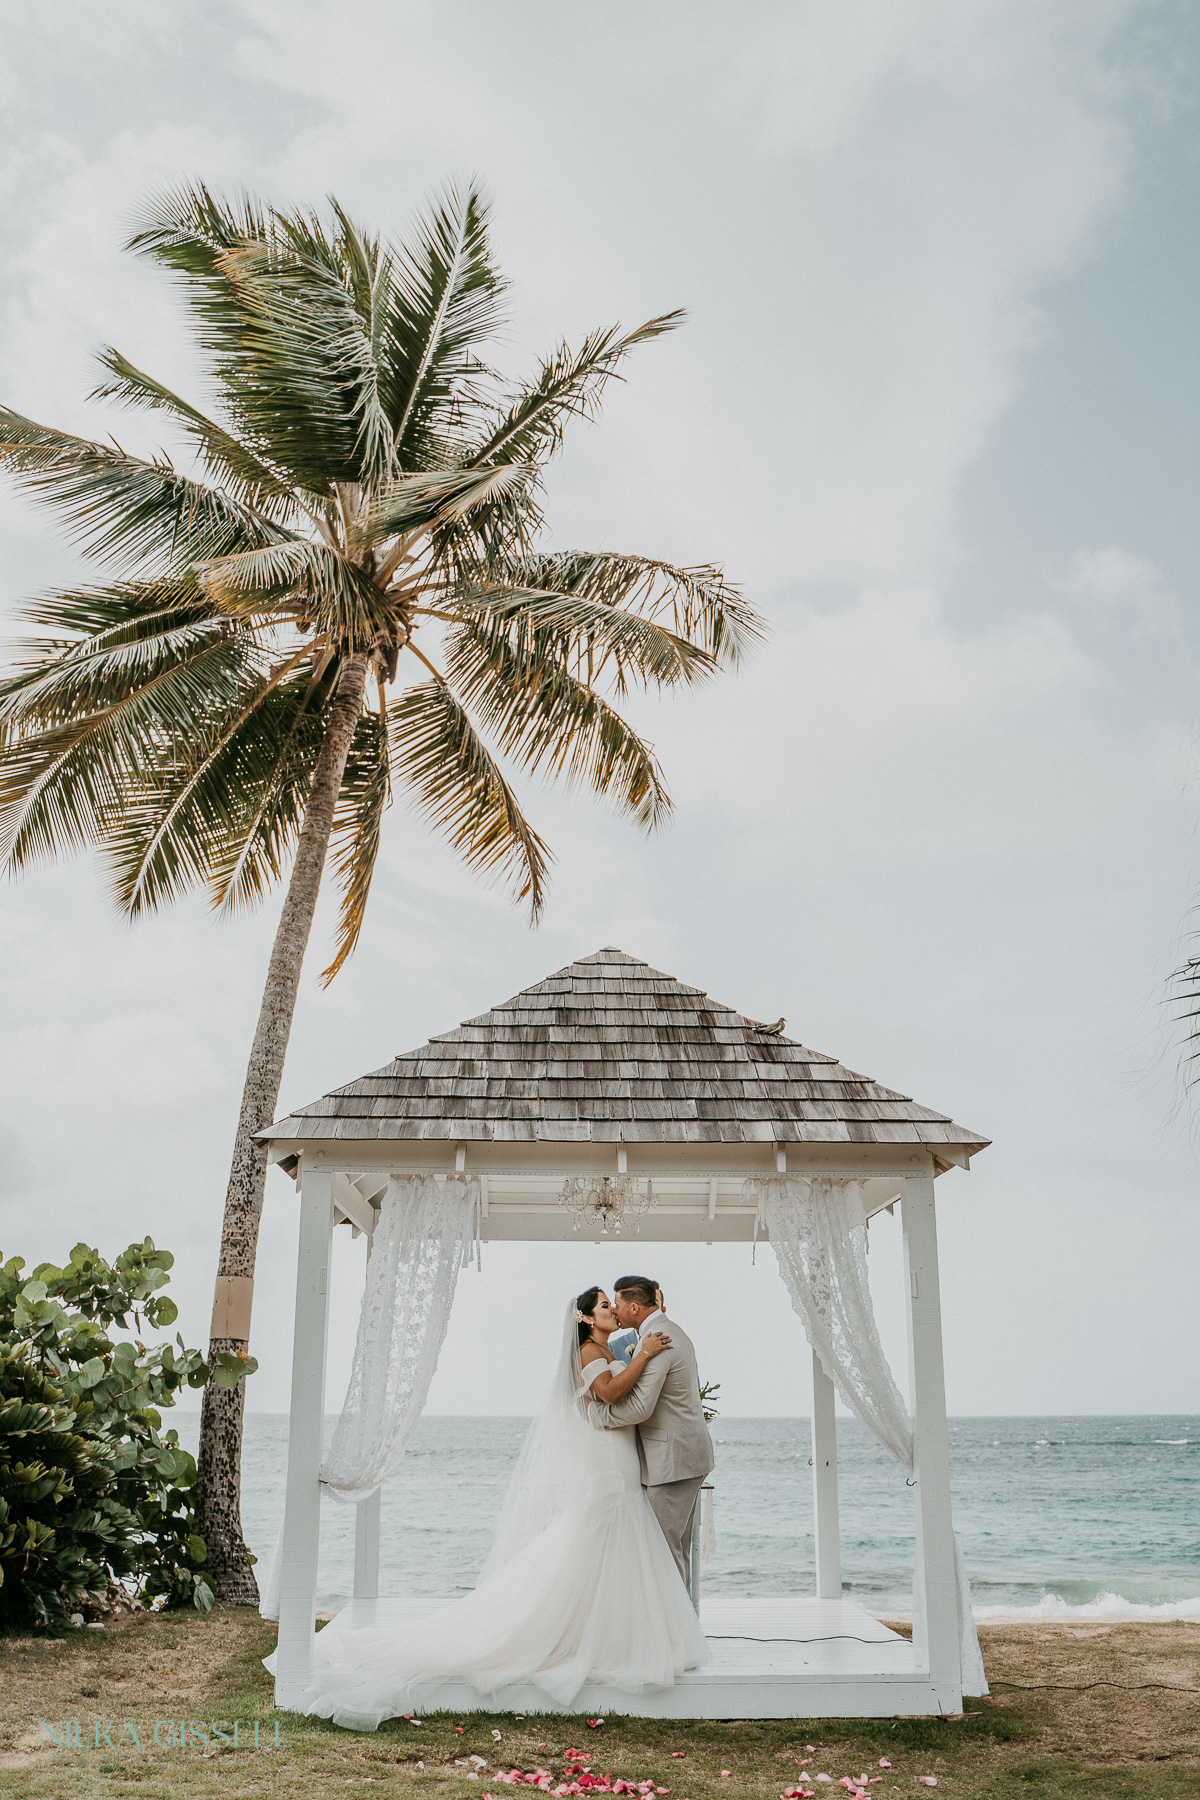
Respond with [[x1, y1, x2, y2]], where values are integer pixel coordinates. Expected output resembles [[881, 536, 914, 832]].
[[0, 1607, 1200, 1800]]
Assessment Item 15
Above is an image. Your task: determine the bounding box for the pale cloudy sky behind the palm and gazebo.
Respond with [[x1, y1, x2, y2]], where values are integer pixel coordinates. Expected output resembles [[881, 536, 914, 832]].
[[0, 0, 1200, 1415]]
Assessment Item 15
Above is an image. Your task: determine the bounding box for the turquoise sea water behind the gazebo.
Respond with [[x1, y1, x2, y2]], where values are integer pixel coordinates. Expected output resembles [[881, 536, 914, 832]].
[[180, 1413, 1200, 1620]]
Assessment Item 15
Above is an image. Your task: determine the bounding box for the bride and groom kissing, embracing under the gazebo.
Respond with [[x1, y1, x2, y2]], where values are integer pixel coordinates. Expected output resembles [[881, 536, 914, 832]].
[[297, 1276, 714, 1732]]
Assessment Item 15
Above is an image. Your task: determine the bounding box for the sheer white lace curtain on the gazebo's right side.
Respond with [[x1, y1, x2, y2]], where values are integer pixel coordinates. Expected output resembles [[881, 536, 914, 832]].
[[745, 1175, 988, 1694]]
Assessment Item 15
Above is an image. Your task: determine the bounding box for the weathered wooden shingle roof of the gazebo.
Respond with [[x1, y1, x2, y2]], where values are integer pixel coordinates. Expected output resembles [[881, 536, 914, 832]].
[[263, 949, 988, 1150]]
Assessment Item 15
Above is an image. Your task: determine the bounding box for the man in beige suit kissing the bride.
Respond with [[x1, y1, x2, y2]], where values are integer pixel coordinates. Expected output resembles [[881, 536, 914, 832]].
[[592, 1274, 716, 1586]]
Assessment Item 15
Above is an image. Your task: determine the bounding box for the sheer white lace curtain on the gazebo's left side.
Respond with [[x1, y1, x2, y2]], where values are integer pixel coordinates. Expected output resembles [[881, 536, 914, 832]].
[[259, 1175, 479, 1618]]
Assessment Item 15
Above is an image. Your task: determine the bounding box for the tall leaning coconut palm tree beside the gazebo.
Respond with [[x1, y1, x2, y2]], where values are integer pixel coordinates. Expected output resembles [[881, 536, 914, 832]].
[[0, 184, 759, 1602]]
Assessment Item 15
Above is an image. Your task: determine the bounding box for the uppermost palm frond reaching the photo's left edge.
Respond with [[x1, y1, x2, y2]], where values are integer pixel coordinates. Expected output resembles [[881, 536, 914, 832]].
[[0, 407, 286, 569]]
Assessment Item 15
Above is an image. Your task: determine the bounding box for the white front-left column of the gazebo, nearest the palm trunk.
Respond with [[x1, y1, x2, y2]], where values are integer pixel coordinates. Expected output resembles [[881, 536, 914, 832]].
[[275, 1157, 333, 1706]]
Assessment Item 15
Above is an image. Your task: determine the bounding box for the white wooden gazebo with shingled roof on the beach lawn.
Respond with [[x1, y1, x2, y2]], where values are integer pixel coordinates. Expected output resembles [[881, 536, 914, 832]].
[[263, 949, 988, 1719]]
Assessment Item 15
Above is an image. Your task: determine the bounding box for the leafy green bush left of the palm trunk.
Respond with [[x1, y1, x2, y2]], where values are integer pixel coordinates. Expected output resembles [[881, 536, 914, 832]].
[[0, 1238, 255, 1631]]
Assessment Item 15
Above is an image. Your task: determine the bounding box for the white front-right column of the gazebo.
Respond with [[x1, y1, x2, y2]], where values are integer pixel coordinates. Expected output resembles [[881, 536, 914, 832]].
[[901, 1170, 963, 1712]]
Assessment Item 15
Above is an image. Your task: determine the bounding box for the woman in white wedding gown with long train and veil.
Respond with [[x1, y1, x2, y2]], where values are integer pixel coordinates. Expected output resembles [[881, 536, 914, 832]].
[[278, 1287, 709, 1732]]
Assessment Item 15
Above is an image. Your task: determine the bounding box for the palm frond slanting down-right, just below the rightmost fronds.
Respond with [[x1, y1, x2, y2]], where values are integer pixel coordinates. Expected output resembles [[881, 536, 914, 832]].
[[446, 612, 671, 832]]
